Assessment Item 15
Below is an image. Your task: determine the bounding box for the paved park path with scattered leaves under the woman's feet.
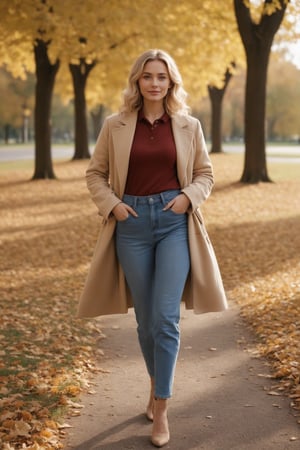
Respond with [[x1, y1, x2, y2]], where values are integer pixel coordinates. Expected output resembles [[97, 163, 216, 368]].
[[66, 305, 300, 450]]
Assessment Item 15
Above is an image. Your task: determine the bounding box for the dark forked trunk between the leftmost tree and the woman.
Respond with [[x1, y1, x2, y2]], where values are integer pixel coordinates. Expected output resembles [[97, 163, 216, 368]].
[[69, 59, 95, 159]]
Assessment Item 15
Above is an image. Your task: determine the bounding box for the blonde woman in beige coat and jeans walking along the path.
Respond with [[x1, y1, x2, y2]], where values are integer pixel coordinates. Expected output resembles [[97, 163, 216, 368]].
[[79, 50, 227, 447]]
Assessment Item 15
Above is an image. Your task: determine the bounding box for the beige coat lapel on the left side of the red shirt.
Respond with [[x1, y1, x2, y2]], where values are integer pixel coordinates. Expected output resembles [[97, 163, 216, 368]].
[[112, 112, 137, 198]]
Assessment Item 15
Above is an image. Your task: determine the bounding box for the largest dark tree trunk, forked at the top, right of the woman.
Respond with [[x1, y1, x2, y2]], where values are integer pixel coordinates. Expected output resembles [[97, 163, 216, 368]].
[[234, 0, 286, 183]]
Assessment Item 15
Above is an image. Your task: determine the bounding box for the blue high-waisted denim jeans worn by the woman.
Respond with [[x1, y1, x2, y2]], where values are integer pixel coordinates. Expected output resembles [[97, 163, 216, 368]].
[[116, 190, 190, 398]]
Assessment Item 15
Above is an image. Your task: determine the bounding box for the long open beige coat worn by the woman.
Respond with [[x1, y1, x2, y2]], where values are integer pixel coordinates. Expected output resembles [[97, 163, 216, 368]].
[[78, 113, 227, 317]]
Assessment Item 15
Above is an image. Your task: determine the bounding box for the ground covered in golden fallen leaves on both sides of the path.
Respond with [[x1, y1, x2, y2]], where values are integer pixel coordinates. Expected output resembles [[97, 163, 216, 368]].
[[0, 155, 300, 450]]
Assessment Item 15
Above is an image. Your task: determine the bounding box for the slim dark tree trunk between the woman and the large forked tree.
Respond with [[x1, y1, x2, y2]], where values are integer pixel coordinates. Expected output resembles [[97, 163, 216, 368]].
[[208, 69, 232, 153]]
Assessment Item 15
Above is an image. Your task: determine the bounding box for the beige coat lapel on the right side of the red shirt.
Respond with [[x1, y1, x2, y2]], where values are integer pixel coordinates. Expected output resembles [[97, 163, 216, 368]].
[[172, 114, 193, 188]]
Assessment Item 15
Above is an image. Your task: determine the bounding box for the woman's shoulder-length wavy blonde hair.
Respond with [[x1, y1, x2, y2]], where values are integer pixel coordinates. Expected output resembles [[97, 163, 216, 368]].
[[120, 49, 189, 116]]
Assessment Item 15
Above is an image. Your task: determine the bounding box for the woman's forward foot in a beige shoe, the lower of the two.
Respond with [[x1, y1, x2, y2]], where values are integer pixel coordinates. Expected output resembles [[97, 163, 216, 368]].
[[151, 398, 170, 447]]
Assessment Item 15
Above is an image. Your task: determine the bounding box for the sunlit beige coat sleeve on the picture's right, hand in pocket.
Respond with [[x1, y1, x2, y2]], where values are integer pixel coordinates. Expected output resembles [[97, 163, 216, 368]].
[[182, 118, 214, 211]]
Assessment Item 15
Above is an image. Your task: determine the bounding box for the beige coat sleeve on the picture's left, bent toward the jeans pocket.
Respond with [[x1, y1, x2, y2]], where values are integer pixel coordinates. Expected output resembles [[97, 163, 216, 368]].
[[86, 117, 121, 219]]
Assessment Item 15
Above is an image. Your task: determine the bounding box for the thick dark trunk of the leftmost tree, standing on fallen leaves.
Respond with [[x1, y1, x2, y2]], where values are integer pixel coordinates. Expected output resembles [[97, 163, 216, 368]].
[[32, 40, 59, 180]]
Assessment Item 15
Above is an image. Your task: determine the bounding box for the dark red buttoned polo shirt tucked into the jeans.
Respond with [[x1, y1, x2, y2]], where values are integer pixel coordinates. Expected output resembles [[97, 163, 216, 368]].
[[125, 111, 180, 195]]
